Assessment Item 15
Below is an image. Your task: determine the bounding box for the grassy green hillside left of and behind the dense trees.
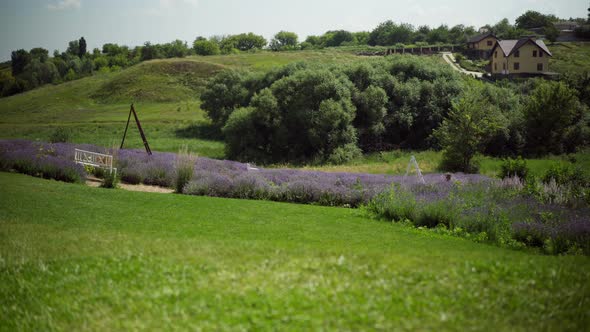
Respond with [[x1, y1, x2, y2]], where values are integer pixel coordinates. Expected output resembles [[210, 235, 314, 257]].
[[0, 50, 356, 158]]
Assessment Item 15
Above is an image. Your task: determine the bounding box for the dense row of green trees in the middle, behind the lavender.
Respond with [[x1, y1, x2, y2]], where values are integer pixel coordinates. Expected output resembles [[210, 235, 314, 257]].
[[201, 56, 590, 167]]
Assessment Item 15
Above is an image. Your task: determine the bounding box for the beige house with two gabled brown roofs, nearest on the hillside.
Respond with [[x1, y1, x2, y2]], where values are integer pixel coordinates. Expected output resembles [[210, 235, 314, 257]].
[[490, 38, 553, 75]]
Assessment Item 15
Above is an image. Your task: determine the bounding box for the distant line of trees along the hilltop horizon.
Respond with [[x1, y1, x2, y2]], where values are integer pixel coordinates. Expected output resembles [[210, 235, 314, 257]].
[[0, 11, 590, 96]]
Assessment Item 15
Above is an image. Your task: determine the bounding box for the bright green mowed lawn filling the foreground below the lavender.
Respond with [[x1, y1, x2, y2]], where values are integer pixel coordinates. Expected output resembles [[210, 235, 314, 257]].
[[0, 173, 590, 331]]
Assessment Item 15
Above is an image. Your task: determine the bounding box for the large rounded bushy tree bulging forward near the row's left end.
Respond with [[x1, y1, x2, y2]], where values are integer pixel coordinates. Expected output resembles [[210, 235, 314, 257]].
[[224, 69, 358, 162]]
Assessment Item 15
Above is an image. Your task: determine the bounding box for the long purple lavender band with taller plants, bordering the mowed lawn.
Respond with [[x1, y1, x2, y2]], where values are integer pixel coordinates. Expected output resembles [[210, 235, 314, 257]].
[[0, 140, 590, 254]]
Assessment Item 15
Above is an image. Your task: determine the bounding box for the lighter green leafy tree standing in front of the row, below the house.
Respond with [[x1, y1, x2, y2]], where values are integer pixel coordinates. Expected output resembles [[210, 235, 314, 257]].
[[434, 83, 499, 173]]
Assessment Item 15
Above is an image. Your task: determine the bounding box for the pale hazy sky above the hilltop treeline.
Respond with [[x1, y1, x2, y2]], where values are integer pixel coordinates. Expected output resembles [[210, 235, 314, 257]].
[[0, 0, 590, 61]]
